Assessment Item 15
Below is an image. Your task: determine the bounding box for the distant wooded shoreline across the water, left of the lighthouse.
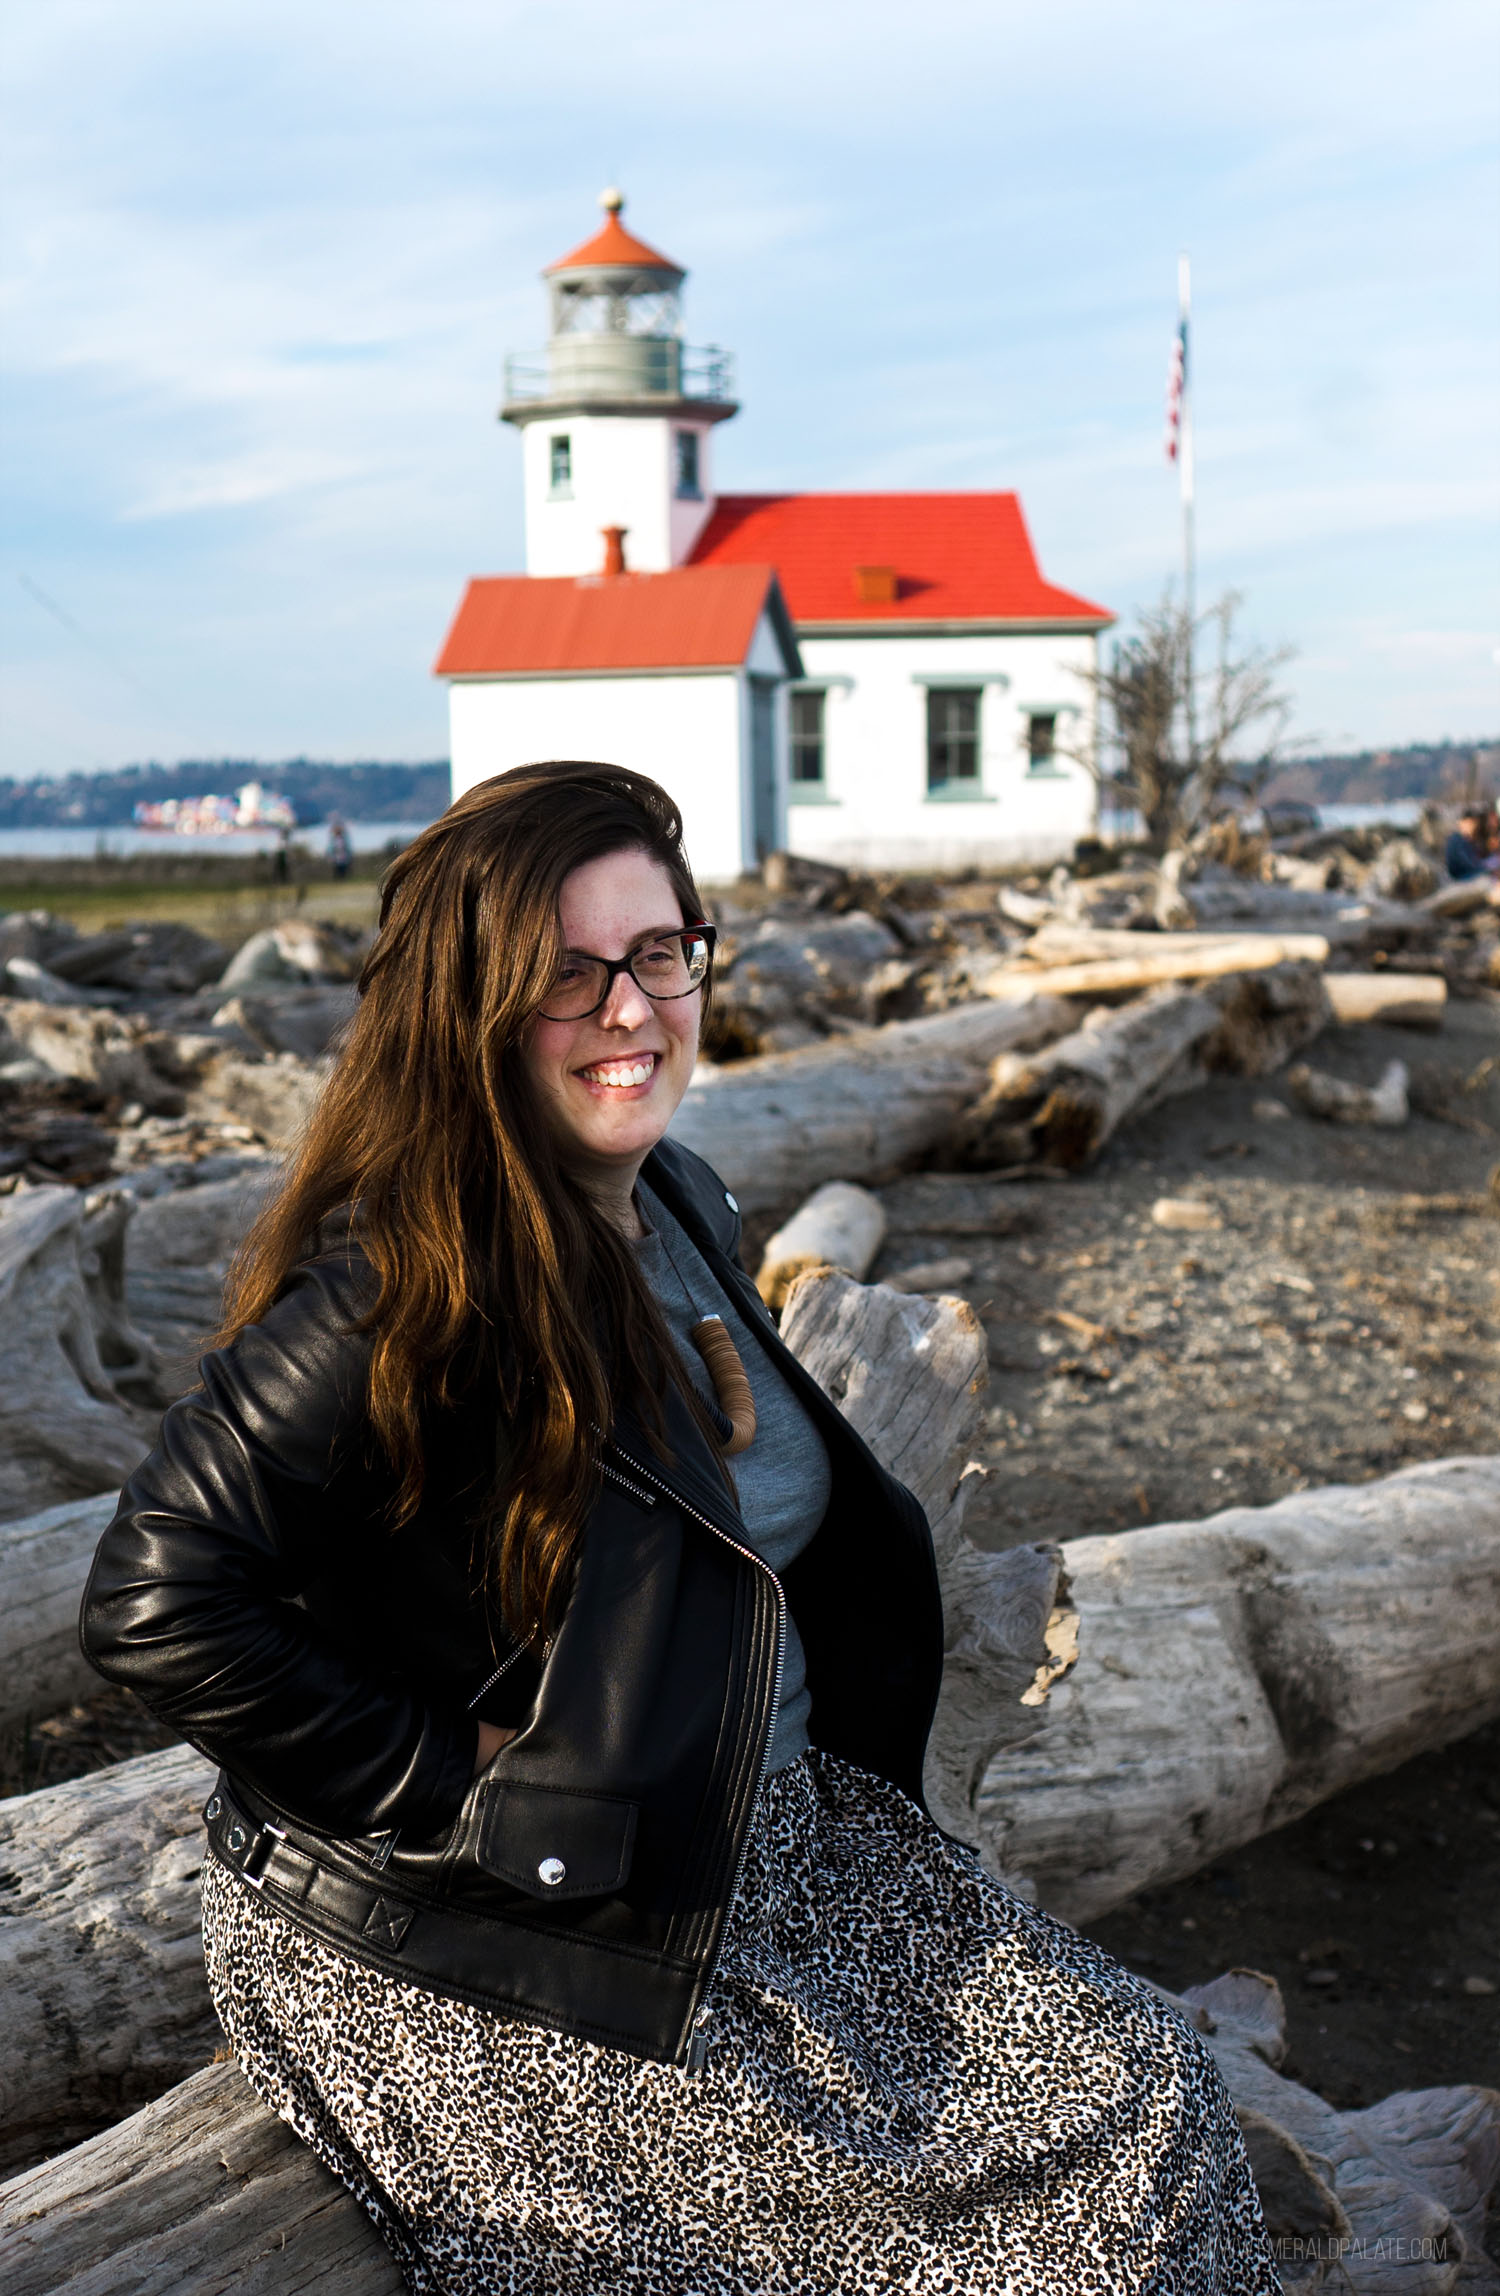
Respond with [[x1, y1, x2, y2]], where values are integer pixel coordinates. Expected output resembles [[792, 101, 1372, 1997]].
[[0, 758, 450, 829]]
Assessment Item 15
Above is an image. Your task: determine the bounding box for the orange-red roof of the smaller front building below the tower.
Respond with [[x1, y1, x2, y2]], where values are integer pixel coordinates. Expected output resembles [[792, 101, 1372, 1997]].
[[434, 563, 797, 677]]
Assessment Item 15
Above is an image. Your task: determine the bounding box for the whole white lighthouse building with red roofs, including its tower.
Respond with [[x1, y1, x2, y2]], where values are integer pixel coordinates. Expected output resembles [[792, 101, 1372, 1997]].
[[436, 193, 1114, 882]]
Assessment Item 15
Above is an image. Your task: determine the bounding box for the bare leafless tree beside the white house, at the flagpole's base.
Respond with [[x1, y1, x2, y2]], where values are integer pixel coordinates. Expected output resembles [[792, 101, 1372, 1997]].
[[1073, 590, 1291, 854]]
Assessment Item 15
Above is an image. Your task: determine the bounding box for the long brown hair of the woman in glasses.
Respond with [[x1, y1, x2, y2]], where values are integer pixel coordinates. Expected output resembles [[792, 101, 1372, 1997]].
[[218, 760, 712, 1635]]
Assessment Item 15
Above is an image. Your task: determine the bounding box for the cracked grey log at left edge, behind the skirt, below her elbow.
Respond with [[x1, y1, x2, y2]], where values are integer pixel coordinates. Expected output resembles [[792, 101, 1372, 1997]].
[[0, 1747, 218, 2176]]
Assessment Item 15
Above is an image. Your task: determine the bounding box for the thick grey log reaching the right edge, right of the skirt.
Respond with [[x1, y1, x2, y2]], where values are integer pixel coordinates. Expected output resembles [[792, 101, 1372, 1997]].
[[960, 1458, 1500, 1922]]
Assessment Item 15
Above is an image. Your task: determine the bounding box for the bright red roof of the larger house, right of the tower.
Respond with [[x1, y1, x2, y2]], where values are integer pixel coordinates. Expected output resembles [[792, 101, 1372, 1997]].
[[691, 494, 1114, 629]]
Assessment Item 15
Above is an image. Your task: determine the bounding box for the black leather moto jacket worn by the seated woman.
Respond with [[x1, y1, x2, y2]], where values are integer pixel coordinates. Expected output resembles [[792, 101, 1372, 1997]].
[[80, 1141, 942, 2064]]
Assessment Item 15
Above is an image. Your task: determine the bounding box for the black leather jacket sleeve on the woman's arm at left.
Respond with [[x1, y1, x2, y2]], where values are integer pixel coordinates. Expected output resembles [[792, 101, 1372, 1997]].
[[80, 1261, 478, 1835]]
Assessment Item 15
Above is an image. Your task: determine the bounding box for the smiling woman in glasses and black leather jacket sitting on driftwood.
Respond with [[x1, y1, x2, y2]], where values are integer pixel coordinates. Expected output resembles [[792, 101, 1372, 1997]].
[[83, 765, 1277, 2296]]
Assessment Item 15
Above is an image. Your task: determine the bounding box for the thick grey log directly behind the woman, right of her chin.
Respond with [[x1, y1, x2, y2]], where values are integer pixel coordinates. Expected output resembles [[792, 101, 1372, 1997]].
[[671, 994, 1077, 1212]]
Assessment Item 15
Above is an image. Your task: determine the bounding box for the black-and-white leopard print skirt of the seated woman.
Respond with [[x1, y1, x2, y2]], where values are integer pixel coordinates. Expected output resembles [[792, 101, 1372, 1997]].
[[204, 1754, 1279, 2296]]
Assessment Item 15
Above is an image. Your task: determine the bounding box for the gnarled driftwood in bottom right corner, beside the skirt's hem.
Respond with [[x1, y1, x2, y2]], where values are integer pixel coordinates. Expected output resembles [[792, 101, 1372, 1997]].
[[1158, 1970, 1500, 2296]]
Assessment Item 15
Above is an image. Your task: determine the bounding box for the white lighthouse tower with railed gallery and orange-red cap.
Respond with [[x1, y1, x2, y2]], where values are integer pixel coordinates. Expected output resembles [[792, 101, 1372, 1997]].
[[501, 191, 737, 574]]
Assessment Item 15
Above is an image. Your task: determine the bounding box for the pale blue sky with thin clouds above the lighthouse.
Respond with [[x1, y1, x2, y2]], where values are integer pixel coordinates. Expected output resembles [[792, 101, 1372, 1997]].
[[0, 0, 1500, 776]]
